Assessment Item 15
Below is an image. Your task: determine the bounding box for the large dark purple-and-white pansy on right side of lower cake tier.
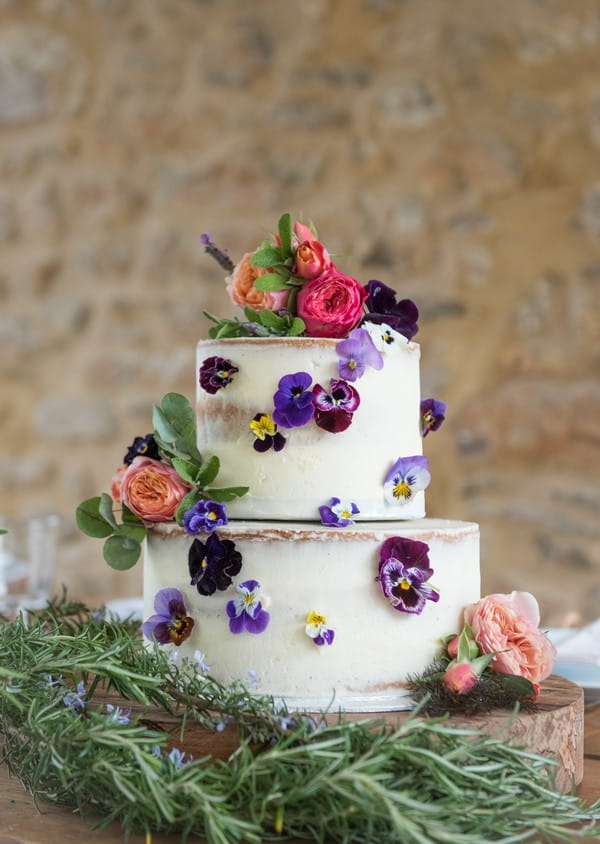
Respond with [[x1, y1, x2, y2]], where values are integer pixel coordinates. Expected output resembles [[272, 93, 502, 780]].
[[376, 536, 440, 615]]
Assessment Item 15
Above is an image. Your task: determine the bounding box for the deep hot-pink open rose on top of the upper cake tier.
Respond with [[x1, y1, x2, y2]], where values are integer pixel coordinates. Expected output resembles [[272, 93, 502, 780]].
[[297, 265, 369, 337]]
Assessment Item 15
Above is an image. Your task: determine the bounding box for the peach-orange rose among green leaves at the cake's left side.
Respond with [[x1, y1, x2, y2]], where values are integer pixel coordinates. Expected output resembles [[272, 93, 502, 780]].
[[121, 457, 190, 522]]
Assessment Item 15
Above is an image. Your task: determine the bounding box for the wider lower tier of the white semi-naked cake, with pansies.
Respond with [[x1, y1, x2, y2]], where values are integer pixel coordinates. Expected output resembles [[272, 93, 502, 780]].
[[144, 519, 480, 712]]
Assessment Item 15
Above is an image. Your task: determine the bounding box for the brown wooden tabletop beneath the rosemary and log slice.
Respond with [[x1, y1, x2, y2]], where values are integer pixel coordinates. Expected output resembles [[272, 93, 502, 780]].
[[0, 700, 600, 844]]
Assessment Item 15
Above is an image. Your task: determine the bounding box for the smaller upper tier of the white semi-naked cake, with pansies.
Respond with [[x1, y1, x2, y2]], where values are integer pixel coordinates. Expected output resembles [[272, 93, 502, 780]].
[[196, 337, 429, 521]]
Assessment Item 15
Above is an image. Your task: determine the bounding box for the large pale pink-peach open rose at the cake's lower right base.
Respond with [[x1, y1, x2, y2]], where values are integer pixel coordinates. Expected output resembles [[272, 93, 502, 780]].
[[465, 592, 556, 683]]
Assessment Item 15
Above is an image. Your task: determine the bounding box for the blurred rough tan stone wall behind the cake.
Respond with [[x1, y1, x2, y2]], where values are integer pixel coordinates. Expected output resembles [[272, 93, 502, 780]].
[[0, 0, 600, 625]]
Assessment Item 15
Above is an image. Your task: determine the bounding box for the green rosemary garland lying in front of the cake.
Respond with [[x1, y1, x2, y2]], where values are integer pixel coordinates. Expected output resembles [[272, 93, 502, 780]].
[[0, 595, 600, 844]]
